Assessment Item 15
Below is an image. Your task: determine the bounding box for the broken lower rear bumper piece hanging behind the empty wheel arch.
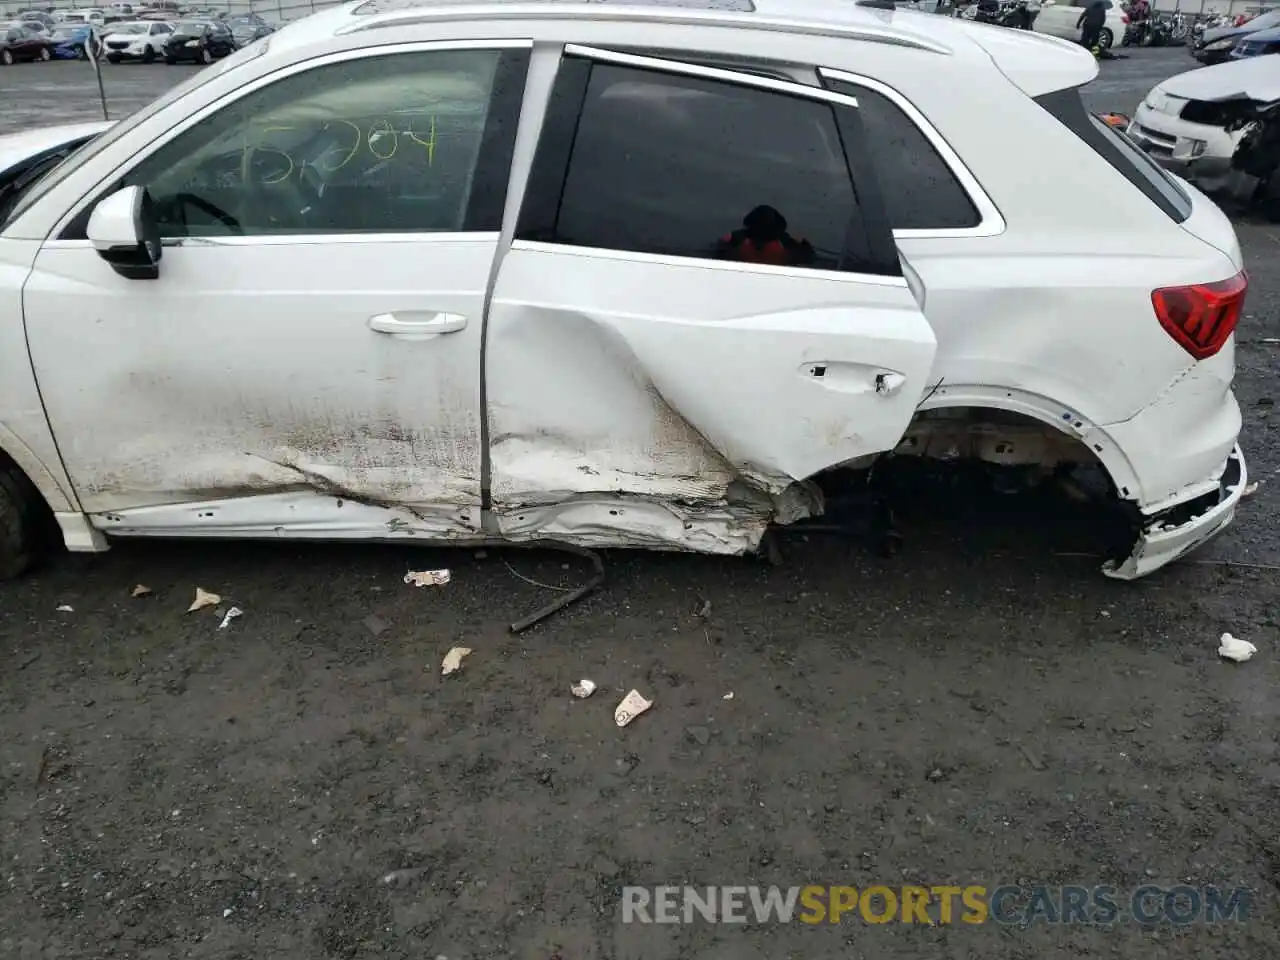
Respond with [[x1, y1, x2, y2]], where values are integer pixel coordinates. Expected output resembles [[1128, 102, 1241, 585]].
[[1102, 444, 1249, 580]]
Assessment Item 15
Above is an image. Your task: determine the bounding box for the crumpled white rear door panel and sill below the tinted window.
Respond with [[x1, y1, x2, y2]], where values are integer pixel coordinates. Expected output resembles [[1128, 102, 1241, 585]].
[[486, 242, 934, 553]]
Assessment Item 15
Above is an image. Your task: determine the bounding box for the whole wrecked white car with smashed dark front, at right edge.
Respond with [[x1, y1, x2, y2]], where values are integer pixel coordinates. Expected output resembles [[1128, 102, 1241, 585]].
[[1128, 56, 1280, 218]]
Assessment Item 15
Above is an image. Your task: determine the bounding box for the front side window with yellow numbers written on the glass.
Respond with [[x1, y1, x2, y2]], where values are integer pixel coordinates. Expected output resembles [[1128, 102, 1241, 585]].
[[113, 50, 527, 238]]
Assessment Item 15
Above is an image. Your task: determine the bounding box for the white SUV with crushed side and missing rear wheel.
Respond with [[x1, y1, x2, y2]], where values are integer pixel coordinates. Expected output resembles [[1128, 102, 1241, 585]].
[[0, 0, 1247, 579]]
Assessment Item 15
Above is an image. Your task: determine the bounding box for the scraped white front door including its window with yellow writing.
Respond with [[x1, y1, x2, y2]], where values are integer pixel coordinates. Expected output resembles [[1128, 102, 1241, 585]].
[[24, 42, 529, 536]]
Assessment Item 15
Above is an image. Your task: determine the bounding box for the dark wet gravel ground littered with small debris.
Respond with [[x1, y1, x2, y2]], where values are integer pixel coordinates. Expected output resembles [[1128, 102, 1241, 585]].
[[0, 50, 1280, 960]]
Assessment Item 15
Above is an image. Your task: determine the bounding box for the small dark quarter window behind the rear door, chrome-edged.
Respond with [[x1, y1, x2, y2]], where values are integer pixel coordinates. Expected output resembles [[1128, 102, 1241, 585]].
[[826, 79, 982, 230]]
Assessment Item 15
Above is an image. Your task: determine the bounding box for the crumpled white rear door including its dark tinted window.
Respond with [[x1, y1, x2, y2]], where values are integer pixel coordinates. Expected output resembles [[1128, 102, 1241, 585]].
[[485, 46, 936, 529]]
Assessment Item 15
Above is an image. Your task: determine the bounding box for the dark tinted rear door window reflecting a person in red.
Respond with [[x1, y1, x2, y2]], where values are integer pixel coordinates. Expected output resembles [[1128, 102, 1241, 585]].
[[543, 64, 856, 269]]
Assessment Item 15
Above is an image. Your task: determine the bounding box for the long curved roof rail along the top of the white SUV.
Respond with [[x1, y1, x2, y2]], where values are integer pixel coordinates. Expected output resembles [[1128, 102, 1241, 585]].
[[337, 0, 952, 55]]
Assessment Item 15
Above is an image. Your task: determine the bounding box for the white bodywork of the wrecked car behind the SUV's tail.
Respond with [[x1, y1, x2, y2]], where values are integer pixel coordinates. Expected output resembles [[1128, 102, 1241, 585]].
[[1128, 56, 1280, 191]]
